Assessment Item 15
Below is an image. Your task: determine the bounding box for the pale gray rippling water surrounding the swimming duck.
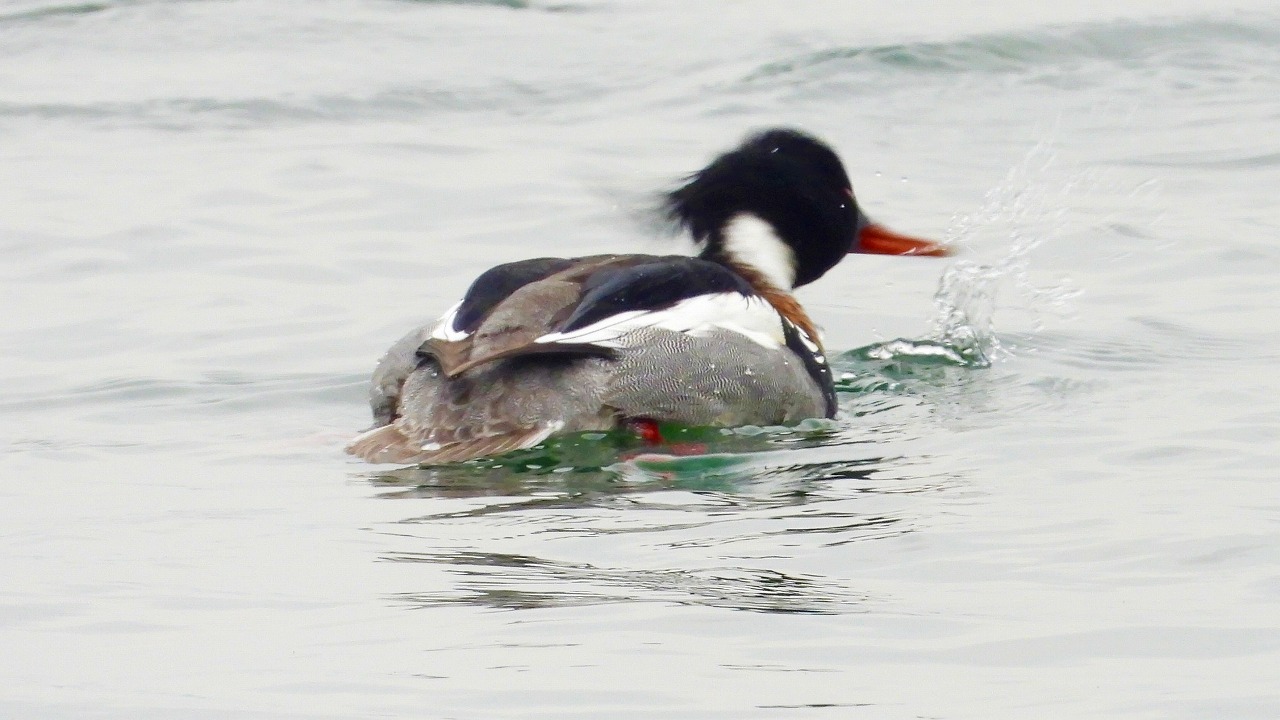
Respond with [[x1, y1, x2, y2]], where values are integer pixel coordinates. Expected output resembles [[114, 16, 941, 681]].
[[0, 0, 1280, 719]]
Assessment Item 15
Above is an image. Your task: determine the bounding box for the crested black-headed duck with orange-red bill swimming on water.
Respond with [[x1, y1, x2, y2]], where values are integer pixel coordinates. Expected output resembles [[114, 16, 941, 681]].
[[347, 128, 948, 465]]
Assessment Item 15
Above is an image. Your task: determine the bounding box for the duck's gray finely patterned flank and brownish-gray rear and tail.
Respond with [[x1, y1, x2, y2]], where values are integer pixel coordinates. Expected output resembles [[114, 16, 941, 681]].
[[349, 322, 824, 462]]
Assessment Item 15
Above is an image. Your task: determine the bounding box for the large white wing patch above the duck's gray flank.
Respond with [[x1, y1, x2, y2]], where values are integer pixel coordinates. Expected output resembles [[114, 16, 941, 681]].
[[534, 292, 786, 348]]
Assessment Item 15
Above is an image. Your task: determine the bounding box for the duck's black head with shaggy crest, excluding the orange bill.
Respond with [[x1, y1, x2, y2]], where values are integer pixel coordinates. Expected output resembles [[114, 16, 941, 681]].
[[667, 128, 860, 287]]
